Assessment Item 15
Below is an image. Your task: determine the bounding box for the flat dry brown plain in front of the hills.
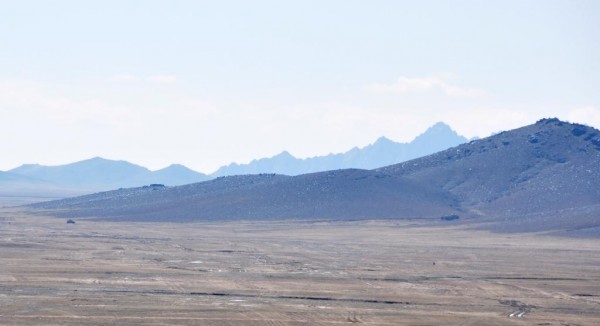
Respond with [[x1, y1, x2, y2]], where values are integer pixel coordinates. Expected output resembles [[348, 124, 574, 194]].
[[0, 209, 600, 325]]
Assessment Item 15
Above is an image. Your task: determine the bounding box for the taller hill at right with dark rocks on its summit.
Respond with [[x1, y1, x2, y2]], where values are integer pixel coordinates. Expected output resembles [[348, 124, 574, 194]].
[[377, 119, 600, 230]]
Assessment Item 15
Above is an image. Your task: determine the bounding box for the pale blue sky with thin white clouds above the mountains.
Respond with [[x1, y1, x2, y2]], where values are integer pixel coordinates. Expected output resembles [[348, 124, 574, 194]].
[[0, 0, 600, 173]]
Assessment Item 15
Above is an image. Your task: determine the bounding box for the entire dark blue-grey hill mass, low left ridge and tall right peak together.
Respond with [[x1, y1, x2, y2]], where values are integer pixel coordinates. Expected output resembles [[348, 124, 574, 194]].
[[31, 119, 600, 236]]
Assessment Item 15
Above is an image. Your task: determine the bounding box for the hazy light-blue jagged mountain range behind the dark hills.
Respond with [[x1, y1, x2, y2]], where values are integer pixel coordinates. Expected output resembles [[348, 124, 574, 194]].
[[0, 123, 467, 197]]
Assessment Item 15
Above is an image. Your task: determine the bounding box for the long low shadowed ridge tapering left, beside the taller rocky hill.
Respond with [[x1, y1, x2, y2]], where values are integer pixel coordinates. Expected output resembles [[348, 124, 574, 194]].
[[28, 169, 456, 221]]
